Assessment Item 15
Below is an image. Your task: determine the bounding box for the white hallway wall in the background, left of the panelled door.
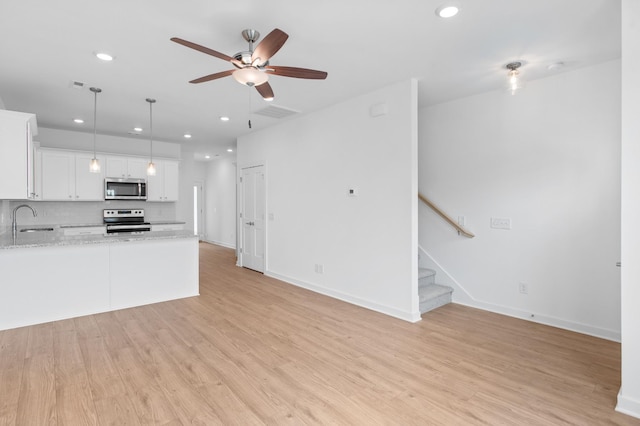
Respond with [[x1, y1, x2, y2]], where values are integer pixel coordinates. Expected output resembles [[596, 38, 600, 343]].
[[205, 158, 236, 248]]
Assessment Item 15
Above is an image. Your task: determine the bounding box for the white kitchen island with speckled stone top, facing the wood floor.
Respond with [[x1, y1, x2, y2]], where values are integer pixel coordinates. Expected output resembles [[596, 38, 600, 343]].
[[0, 228, 199, 330]]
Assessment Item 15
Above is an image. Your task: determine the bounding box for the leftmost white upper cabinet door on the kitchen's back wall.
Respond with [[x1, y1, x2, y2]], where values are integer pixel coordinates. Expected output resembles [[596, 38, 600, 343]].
[[42, 151, 75, 201]]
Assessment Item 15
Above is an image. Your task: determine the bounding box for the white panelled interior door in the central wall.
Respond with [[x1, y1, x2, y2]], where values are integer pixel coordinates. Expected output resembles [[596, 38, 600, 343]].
[[240, 166, 266, 272]]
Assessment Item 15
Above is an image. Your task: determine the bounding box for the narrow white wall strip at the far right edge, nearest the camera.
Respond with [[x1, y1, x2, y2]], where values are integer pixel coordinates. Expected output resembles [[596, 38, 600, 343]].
[[616, 0, 640, 418]]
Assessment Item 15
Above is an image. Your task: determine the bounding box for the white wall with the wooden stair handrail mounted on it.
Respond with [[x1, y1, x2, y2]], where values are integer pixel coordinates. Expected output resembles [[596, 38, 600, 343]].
[[419, 61, 624, 340]]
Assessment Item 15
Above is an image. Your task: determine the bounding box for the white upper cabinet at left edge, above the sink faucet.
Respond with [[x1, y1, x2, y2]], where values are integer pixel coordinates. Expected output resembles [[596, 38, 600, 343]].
[[0, 110, 38, 200]]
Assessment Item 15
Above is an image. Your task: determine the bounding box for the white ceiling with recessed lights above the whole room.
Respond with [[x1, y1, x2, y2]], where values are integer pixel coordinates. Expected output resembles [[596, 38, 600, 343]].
[[0, 0, 620, 160]]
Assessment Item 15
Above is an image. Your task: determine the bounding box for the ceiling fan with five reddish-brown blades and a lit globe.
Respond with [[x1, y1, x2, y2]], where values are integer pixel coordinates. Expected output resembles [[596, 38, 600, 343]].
[[171, 28, 327, 100]]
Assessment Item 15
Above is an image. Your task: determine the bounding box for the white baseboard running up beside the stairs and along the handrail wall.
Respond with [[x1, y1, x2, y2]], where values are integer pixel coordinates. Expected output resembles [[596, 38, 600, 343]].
[[418, 247, 622, 343]]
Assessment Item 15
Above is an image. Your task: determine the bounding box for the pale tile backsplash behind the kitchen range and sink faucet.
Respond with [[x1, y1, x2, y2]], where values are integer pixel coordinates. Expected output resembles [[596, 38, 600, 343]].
[[0, 200, 176, 233]]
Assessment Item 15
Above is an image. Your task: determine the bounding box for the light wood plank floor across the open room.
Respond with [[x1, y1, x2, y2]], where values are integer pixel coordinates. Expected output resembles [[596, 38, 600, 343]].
[[0, 244, 640, 425]]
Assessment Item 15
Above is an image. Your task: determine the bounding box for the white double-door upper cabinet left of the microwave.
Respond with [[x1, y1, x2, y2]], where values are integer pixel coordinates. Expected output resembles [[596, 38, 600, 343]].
[[39, 150, 105, 201]]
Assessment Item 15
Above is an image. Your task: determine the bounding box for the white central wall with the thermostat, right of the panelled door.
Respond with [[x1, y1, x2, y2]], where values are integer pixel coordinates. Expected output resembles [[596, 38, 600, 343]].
[[237, 81, 420, 321]]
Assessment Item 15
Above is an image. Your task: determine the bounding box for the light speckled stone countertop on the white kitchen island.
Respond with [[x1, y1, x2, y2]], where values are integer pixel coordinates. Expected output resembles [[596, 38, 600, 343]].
[[0, 230, 197, 250]]
